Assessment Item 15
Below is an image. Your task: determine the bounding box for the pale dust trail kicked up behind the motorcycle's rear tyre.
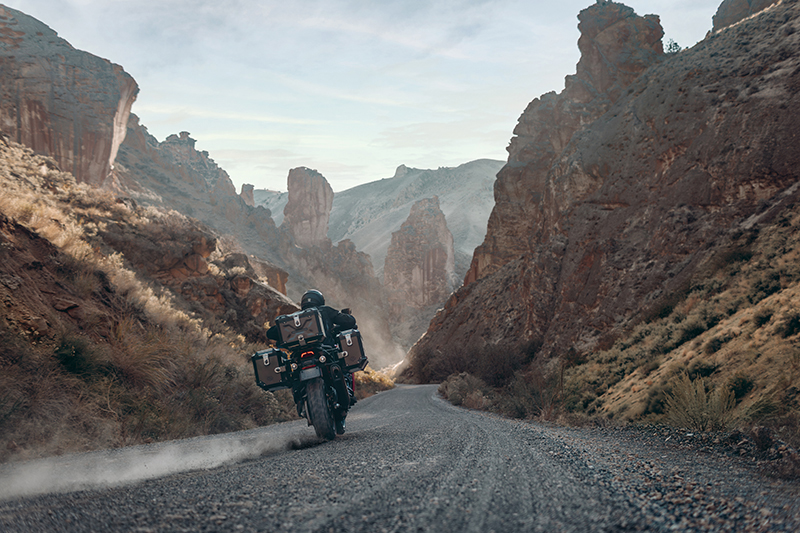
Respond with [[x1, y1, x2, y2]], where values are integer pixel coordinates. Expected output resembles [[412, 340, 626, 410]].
[[0, 423, 317, 500]]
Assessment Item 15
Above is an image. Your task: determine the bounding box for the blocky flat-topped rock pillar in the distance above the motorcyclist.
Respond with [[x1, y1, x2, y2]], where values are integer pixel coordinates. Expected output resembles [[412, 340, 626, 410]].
[[281, 167, 333, 247]]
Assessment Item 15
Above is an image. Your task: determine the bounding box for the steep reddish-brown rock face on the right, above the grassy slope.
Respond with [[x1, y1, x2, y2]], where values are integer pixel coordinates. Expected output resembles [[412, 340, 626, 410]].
[[411, 2, 800, 379]]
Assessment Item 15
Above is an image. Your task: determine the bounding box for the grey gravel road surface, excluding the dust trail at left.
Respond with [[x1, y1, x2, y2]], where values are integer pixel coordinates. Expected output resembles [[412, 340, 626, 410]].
[[0, 386, 797, 533]]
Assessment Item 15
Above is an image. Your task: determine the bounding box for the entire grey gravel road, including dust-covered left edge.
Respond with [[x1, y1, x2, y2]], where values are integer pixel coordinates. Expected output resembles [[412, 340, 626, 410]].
[[0, 386, 800, 533]]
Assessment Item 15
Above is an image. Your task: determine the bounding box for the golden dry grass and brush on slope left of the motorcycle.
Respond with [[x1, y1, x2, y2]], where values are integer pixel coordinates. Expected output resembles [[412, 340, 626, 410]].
[[0, 141, 302, 461]]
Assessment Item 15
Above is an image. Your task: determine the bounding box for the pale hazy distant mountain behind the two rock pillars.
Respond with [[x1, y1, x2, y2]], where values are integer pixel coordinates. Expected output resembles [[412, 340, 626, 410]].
[[253, 159, 504, 279]]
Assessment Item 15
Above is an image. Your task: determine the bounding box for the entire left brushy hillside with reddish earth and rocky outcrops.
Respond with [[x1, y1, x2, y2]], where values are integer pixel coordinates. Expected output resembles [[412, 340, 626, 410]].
[[0, 143, 294, 459]]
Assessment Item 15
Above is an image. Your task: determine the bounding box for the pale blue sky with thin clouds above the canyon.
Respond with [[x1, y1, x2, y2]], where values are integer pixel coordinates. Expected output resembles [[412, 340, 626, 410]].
[[12, 0, 721, 191]]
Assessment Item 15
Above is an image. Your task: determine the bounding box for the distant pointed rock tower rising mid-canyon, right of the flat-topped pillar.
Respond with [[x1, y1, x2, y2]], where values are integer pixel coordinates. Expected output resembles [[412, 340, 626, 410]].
[[383, 196, 455, 314]]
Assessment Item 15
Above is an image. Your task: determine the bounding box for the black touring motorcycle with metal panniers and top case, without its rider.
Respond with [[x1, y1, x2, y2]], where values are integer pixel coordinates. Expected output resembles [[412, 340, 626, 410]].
[[251, 308, 367, 440]]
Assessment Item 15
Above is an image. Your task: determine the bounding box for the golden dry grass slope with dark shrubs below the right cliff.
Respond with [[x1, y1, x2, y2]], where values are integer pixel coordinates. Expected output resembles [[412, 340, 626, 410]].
[[565, 206, 800, 426]]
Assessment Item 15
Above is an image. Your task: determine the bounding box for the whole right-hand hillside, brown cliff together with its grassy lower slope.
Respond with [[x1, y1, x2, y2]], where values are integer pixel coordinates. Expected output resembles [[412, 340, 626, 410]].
[[405, 2, 800, 436]]
